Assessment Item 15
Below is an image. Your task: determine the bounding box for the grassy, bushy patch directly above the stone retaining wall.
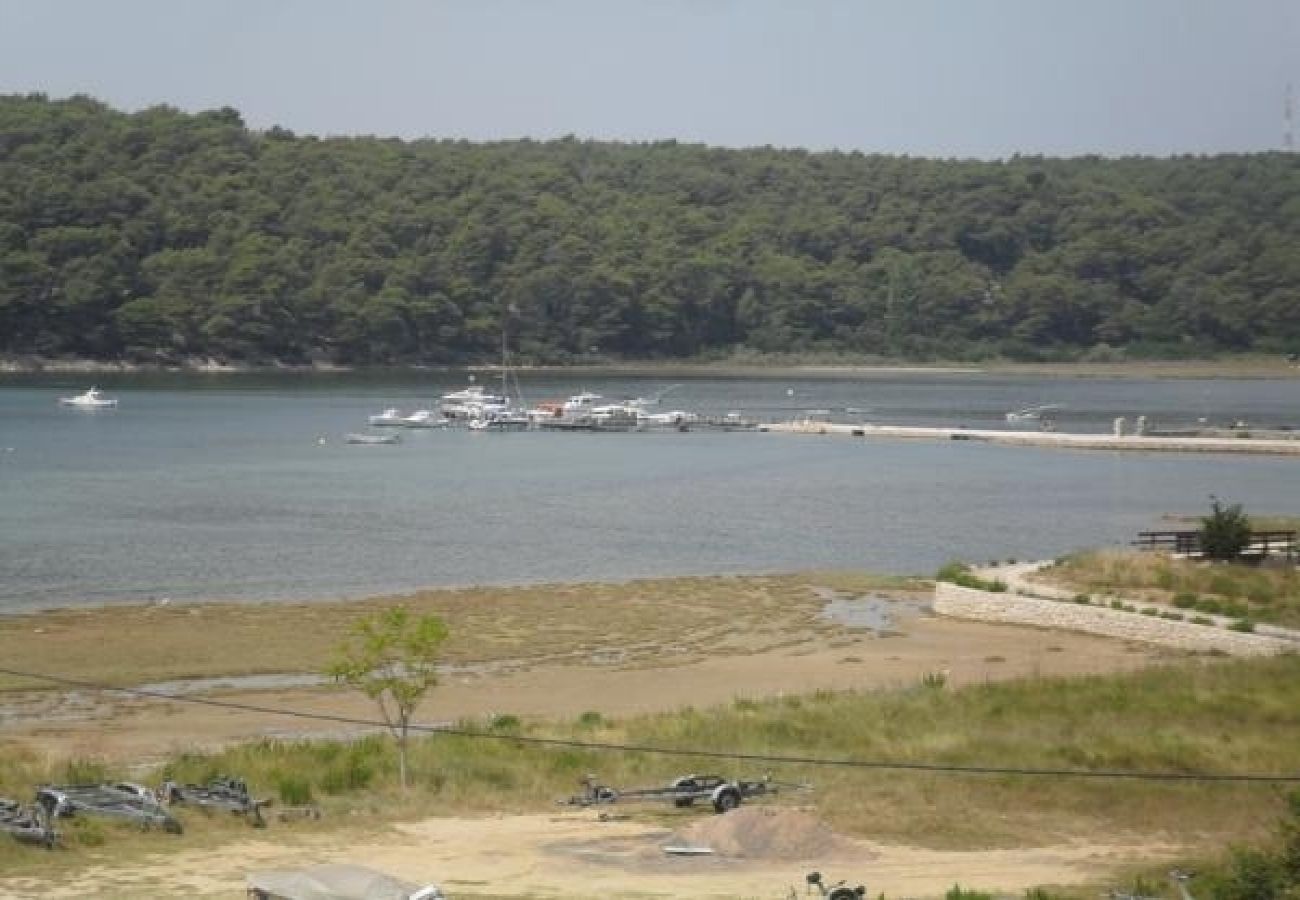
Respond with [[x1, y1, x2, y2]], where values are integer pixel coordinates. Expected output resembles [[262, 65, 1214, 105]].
[[1047, 550, 1300, 628]]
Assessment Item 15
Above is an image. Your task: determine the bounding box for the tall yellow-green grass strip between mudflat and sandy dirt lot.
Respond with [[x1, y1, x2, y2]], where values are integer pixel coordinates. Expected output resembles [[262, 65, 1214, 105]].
[[0, 657, 1300, 865]]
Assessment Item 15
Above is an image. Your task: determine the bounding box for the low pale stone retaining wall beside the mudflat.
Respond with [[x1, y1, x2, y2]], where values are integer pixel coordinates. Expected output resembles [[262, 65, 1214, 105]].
[[935, 581, 1296, 657]]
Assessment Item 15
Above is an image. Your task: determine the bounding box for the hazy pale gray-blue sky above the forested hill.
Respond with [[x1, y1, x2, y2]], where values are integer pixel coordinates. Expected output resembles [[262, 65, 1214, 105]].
[[0, 0, 1300, 156]]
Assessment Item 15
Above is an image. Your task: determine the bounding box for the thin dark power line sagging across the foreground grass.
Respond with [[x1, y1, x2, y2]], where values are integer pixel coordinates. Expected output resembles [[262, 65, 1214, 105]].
[[0, 668, 1300, 784]]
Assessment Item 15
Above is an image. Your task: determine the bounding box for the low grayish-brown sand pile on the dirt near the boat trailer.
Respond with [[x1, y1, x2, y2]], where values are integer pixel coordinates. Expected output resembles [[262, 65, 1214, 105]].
[[671, 806, 845, 860]]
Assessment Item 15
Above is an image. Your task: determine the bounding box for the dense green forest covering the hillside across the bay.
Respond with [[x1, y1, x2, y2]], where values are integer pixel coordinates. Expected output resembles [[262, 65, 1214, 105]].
[[0, 89, 1300, 364]]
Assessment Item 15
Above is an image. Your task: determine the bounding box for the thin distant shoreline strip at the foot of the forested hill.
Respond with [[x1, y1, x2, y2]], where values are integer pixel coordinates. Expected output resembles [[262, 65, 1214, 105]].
[[0, 356, 1300, 378]]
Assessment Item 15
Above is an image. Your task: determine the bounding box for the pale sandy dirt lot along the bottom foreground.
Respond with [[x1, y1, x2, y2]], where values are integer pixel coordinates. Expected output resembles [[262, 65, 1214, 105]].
[[0, 812, 1177, 900]]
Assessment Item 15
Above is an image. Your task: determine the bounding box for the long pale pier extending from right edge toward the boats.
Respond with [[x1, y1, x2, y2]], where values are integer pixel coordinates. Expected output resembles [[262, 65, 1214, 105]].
[[759, 421, 1300, 457]]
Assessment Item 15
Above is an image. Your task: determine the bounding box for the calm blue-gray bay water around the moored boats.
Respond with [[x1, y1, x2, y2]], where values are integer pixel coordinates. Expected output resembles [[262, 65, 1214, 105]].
[[0, 373, 1300, 611]]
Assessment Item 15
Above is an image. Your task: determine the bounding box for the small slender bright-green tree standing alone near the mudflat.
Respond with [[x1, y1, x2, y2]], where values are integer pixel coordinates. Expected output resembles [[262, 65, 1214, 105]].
[[326, 606, 447, 791]]
